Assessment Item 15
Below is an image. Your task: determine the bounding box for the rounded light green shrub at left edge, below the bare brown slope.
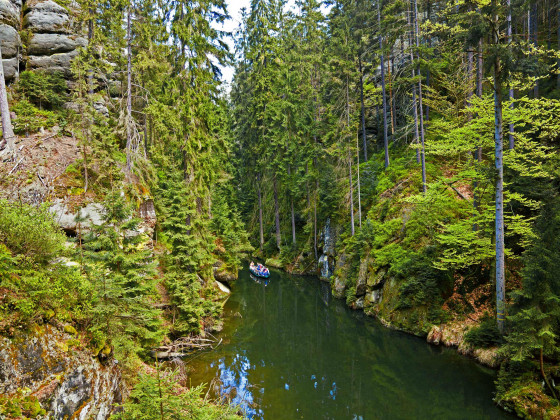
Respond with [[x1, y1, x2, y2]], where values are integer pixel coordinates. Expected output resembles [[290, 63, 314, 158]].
[[0, 200, 66, 262]]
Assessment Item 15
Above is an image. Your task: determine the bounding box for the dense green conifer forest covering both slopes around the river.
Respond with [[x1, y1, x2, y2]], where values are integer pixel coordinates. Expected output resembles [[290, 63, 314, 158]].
[[0, 0, 560, 419]]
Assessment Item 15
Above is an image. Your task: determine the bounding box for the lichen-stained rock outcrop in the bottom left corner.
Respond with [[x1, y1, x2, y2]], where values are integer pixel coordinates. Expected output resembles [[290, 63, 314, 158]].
[[0, 325, 125, 420]]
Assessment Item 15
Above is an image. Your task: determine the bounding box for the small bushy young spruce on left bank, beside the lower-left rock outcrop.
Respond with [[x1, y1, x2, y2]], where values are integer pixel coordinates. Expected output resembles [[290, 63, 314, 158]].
[[82, 191, 163, 354]]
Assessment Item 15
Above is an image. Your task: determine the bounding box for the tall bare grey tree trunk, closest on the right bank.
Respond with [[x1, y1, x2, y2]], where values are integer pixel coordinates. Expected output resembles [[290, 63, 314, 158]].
[[494, 15, 505, 333]]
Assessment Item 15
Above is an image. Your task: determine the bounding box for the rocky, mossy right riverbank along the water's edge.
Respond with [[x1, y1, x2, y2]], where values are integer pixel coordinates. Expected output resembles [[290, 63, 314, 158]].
[[267, 249, 559, 419]]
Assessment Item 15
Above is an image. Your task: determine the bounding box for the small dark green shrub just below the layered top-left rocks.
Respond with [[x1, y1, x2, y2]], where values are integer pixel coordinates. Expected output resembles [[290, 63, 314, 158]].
[[16, 71, 68, 109]]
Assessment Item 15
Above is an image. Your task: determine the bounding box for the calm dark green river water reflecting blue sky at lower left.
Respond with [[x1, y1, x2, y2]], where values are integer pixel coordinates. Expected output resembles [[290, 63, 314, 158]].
[[188, 270, 511, 420]]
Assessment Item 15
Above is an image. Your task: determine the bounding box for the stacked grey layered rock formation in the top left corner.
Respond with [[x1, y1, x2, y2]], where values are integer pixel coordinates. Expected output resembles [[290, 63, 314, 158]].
[[0, 0, 83, 81]]
